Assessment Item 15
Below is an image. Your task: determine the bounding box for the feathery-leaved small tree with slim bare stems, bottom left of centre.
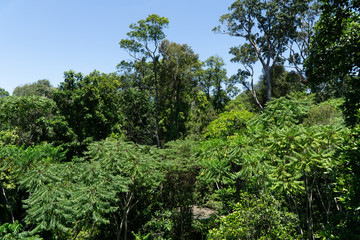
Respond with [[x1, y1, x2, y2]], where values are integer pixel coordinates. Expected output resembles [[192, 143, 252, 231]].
[[86, 138, 164, 239]]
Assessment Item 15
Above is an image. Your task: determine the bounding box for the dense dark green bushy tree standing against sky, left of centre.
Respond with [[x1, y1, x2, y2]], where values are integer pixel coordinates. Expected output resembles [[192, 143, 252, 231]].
[[53, 71, 122, 150]]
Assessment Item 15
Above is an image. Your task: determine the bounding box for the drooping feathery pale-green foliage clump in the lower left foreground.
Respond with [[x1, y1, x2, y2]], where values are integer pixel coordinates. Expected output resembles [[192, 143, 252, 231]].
[[22, 159, 126, 238]]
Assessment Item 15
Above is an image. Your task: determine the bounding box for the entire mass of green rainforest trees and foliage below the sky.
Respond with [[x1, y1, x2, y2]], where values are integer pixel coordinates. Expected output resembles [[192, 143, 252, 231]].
[[0, 0, 360, 240]]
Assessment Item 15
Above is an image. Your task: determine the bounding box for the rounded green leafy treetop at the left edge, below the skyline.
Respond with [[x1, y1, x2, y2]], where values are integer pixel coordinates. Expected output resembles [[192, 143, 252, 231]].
[[0, 96, 72, 146]]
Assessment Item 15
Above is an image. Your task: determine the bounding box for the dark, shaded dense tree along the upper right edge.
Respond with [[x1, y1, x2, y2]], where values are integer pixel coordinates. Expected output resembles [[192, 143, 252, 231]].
[[306, 0, 360, 125]]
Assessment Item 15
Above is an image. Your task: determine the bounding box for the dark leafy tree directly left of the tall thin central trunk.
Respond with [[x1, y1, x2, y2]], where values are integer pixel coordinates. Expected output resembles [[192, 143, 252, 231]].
[[117, 58, 157, 145]]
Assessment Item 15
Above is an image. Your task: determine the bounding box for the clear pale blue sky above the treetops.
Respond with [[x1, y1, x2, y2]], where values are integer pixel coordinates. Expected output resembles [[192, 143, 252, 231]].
[[0, 0, 252, 94]]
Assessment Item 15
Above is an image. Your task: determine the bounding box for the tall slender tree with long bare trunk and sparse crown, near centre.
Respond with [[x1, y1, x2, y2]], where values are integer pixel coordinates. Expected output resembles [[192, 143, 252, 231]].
[[119, 14, 169, 147]]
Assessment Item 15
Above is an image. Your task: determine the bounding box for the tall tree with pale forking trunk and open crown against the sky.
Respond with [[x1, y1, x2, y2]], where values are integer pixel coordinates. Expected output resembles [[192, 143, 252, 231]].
[[214, 0, 306, 101]]
